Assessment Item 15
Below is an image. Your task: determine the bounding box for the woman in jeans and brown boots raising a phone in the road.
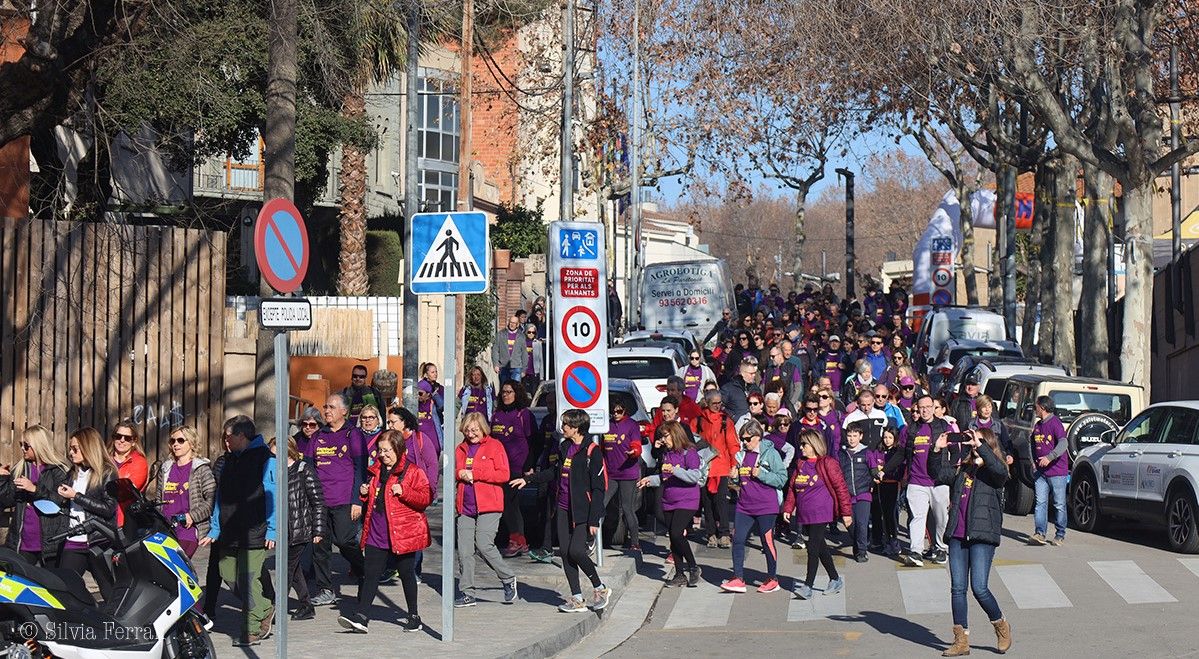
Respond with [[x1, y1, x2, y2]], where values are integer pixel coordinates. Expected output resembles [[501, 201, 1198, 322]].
[[928, 429, 1012, 657]]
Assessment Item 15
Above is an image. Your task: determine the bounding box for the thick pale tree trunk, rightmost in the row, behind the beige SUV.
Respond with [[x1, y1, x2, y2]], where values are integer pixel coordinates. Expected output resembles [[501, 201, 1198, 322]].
[[1119, 179, 1153, 393]]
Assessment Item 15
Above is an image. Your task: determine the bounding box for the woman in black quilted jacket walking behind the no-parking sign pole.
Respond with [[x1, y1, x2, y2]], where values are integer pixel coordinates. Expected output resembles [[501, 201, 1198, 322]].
[[270, 437, 325, 621]]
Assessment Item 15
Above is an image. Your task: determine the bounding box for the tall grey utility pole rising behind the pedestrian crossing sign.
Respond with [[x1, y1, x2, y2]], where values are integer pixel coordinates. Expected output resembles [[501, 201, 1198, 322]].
[[400, 0, 422, 415]]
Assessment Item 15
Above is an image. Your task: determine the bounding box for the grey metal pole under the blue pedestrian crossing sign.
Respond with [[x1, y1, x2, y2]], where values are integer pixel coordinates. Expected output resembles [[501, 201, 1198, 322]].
[[441, 295, 458, 643]]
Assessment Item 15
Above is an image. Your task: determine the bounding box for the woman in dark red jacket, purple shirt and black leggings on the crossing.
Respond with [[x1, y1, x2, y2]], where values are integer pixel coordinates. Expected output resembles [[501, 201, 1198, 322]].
[[783, 430, 854, 599]]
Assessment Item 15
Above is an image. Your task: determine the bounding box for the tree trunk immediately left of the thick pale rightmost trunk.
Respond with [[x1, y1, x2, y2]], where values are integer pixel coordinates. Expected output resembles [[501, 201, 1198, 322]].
[[1078, 164, 1113, 377]]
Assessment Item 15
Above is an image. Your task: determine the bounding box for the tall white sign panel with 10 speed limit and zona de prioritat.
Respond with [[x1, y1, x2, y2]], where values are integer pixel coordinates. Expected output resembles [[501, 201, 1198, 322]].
[[549, 222, 608, 433]]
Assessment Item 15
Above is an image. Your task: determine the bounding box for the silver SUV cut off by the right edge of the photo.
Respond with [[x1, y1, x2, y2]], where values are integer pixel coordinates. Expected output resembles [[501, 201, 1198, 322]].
[[1070, 400, 1199, 554]]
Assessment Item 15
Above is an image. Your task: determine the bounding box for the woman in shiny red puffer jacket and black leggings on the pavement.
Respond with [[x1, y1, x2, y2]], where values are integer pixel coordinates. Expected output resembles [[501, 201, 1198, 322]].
[[337, 430, 433, 634]]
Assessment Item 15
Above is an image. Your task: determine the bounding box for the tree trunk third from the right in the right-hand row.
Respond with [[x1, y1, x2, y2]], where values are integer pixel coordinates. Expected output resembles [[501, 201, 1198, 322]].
[[1049, 155, 1078, 373]]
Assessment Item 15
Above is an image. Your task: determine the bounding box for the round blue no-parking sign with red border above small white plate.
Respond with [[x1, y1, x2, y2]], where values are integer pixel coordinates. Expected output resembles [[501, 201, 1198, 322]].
[[254, 199, 309, 292]]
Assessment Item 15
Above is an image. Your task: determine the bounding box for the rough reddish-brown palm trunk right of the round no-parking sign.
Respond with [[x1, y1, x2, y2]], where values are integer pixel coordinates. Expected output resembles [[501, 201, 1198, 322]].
[[337, 85, 369, 295]]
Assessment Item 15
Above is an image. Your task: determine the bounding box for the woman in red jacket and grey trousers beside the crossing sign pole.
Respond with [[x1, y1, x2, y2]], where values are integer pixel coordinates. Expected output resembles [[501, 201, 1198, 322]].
[[453, 412, 517, 609]]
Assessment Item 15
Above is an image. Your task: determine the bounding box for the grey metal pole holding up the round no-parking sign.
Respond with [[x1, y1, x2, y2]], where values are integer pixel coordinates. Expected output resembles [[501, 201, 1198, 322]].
[[274, 330, 291, 659]]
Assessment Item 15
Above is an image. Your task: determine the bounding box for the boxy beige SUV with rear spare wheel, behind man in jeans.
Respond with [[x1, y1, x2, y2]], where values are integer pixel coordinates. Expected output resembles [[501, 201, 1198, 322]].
[[999, 375, 1145, 515]]
